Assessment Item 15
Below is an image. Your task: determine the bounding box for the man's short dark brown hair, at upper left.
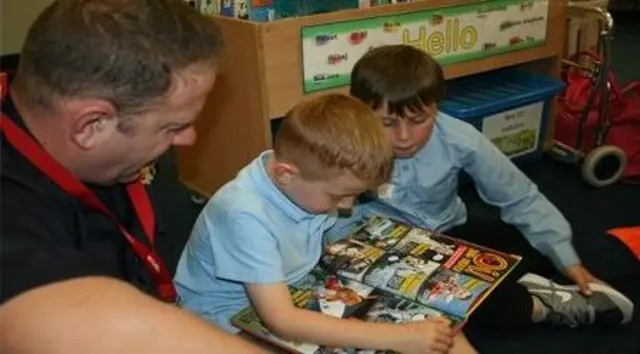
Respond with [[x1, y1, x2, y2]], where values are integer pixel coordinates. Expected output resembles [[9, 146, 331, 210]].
[[15, 0, 222, 116]]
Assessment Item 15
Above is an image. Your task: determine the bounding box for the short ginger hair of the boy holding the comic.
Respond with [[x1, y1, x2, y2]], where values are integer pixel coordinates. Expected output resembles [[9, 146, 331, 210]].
[[274, 94, 393, 186]]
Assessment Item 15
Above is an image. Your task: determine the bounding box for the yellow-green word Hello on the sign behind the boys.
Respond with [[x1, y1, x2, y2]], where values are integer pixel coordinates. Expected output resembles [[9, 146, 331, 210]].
[[402, 19, 478, 56]]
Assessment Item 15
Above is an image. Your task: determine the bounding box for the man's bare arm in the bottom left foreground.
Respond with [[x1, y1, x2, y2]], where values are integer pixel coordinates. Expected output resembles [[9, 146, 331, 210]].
[[0, 277, 264, 354]]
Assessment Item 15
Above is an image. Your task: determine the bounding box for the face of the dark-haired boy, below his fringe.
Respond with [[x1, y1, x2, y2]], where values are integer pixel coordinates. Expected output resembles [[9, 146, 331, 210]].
[[376, 103, 438, 158]]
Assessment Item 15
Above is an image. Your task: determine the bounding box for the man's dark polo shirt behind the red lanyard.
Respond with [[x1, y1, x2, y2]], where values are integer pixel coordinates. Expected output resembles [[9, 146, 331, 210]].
[[0, 97, 173, 303]]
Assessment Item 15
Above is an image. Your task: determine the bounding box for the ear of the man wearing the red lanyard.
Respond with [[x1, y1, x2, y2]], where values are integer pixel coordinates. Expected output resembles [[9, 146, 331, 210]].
[[65, 99, 118, 150]]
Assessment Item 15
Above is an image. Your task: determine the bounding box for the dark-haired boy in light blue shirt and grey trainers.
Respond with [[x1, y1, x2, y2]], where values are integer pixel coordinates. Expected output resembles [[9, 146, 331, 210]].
[[342, 45, 633, 328]]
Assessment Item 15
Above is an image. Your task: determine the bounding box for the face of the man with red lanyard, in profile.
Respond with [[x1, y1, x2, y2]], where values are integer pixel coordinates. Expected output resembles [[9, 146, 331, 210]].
[[87, 65, 215, 184]]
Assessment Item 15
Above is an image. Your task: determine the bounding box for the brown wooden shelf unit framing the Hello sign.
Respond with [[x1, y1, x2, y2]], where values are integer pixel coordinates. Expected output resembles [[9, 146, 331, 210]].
[[177, 0, 565, 197]]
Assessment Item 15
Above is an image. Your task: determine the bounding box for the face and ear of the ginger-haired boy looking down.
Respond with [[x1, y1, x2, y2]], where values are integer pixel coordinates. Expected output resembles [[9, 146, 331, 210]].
[[273, 162, 370, 214]]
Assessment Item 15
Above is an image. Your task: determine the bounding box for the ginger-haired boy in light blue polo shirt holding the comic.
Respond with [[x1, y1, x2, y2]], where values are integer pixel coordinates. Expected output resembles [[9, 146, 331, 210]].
[[175, 94, 475, 354]]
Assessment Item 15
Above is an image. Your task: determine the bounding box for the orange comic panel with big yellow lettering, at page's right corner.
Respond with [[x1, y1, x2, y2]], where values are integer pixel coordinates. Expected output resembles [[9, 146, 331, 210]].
[[443, 246, 519, 283]]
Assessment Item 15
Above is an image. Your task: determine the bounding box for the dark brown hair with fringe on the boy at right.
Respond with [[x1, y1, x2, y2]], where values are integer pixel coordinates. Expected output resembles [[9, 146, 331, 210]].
[[350, 45, 445, 117]]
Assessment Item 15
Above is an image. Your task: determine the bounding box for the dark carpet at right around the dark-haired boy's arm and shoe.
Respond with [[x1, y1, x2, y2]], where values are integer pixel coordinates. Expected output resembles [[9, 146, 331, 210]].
[[463, 157, 640, 354]]
